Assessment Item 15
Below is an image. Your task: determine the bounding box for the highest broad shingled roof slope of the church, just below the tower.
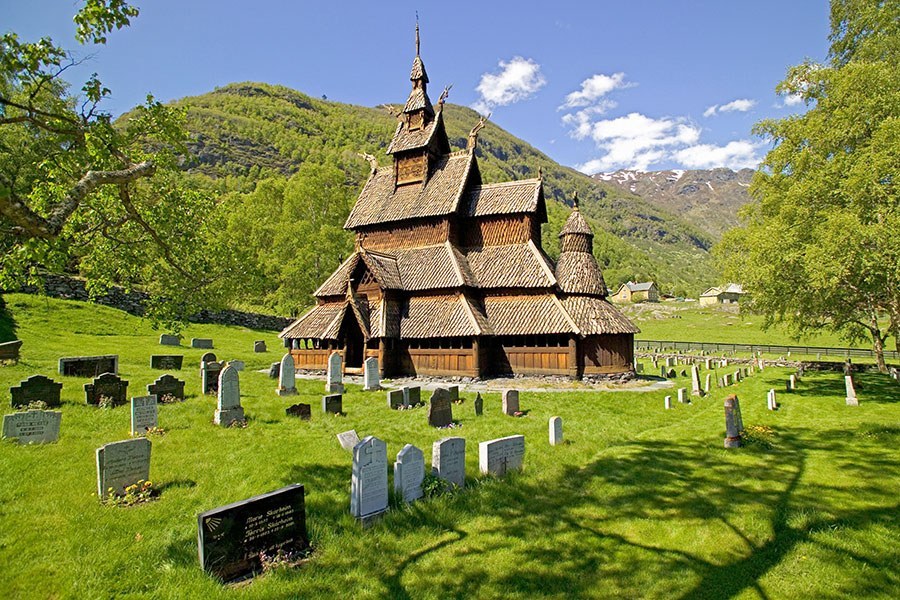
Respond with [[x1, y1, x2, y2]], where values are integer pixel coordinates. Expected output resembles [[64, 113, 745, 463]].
[[344, 150, 475, 229]]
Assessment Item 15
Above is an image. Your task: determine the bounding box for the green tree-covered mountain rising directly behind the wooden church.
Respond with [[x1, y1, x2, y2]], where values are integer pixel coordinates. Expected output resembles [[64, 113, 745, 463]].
[[165, 82, 715, 294]]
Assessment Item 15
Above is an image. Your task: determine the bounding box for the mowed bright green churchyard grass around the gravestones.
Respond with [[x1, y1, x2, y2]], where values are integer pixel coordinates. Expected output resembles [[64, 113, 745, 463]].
[[0, 295, 900, 598]]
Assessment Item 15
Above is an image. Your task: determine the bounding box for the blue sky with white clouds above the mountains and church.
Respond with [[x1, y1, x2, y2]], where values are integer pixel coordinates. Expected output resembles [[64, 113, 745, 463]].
[[0, 0, 828, 173]]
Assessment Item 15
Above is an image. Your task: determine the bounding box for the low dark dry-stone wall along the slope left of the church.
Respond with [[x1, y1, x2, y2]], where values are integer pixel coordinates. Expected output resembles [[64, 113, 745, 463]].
[[11, 275, 293, 331]]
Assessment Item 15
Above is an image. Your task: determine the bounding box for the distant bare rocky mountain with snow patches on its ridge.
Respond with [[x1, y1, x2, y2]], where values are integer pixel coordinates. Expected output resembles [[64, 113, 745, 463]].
[[593, 168, 754, 240]]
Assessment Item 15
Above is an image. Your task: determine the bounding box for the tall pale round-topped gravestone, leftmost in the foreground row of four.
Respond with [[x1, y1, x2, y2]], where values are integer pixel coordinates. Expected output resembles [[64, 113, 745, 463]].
[[350, 435, 388, 519]]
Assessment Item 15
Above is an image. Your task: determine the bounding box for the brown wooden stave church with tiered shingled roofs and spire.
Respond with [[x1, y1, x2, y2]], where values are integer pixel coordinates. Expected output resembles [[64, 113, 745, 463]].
[[280, 26, 639, 378]]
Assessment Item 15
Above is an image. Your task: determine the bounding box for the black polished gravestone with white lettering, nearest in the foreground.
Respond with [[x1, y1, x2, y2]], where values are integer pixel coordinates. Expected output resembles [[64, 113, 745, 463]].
[[197, 483, 309, 582]]
